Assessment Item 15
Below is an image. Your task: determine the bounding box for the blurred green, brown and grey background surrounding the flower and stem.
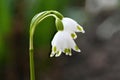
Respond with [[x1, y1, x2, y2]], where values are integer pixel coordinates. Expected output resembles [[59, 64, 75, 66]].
[[0, 0, 120, 80]]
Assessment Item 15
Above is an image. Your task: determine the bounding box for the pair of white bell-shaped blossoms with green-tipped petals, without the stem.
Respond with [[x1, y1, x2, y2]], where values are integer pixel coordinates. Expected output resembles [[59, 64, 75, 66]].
[[50, 17, 85, 57]]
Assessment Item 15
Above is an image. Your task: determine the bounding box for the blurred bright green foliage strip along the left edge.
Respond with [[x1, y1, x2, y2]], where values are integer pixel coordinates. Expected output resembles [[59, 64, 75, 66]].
[[0, 0, 12, 61]]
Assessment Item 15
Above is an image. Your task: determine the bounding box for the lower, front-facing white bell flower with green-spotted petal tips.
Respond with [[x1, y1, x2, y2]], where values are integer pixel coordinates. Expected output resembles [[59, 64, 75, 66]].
[[50, 31, 80, 57]]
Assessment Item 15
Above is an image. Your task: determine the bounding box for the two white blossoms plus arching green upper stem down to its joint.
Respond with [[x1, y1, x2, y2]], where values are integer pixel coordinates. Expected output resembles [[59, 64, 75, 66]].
[[30, 11, 85, 57]]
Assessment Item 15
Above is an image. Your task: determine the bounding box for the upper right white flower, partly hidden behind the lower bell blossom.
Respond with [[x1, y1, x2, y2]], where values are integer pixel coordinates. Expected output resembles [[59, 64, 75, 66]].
[[62, 17, 85, 39]]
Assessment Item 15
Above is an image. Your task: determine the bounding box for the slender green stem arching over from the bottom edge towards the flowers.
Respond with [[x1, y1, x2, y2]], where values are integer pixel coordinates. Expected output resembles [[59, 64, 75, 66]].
[[29, 11, 62, 80]]
